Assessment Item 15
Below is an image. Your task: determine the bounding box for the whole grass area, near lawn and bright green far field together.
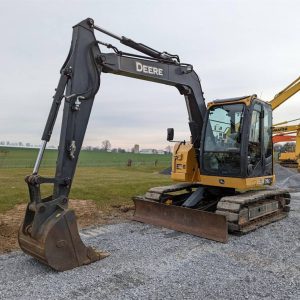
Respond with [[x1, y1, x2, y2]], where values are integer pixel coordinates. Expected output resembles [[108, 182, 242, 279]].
[[0, 148, 171, 212]]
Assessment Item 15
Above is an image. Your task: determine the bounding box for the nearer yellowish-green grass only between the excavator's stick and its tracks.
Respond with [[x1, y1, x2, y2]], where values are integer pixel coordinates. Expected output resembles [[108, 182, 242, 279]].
[[70, 167, 171, 209]]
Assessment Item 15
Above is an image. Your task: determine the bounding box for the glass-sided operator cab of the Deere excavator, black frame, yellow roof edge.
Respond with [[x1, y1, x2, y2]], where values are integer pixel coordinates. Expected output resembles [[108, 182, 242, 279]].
[[200, 95, 273, 178]]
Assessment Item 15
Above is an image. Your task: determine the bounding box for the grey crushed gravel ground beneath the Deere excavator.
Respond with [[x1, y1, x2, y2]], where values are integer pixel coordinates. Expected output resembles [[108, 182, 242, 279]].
[[0, 193, 300, 299]]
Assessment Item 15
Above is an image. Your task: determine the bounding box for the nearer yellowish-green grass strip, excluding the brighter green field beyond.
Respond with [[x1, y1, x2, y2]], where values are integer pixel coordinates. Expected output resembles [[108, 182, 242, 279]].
[[0, 166, 171, 213]]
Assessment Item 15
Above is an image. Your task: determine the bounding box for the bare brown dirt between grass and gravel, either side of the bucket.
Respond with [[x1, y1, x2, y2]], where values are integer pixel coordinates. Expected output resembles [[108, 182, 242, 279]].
[[0, 200, 134, 253]]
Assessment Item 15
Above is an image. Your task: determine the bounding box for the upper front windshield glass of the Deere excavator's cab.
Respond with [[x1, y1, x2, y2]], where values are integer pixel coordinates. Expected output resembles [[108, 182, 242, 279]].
[[204, 104, 244, 152]]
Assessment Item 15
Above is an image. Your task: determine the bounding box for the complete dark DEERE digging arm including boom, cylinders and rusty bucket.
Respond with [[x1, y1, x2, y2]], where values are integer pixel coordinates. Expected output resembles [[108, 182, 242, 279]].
[[19, 19, 206, 270]]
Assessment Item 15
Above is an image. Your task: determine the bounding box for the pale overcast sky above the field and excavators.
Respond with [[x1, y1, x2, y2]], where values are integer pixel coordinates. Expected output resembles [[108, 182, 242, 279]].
[[0, 0, 300, 149]]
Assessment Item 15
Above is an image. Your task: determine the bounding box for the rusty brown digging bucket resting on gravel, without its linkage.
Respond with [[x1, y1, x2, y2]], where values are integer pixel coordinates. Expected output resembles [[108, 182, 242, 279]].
[[18, 208, 109, 271]]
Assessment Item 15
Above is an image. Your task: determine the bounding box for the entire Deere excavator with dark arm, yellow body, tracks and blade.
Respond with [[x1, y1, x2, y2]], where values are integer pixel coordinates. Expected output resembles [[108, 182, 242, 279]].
[[18, 18, 290, 271]]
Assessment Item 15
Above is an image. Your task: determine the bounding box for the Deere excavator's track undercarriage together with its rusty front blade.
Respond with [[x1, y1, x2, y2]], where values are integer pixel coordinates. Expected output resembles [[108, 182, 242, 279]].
[[133, 183, 290, 242]]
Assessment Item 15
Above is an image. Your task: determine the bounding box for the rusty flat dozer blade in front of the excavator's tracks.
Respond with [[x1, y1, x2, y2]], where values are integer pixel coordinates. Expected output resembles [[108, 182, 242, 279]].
[[133, 197, 228, 243]]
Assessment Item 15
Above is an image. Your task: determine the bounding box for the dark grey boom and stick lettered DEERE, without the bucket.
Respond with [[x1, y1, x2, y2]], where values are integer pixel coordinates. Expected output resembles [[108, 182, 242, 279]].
[[44, 19, 206, 202]]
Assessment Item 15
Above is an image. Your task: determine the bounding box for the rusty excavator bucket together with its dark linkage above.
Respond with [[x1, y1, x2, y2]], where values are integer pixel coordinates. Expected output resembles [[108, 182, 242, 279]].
[[18, 171, 109, 271]]
